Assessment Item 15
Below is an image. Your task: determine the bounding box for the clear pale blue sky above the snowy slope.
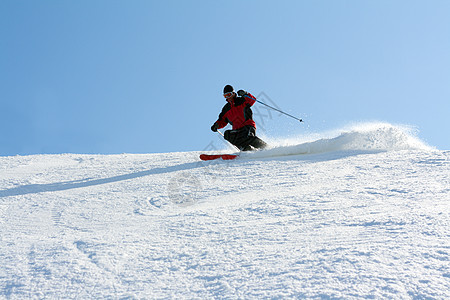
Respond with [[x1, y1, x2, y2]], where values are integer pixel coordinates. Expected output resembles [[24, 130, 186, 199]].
[[0, 0, 450, 155]]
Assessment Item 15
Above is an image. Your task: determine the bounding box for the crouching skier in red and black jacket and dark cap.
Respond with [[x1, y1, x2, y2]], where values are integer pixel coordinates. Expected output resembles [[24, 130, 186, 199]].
[[211, 85, 267, 151]]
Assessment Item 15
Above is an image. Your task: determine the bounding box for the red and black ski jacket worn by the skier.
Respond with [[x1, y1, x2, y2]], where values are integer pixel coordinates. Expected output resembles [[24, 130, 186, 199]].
[[216, 93, 256, 130]]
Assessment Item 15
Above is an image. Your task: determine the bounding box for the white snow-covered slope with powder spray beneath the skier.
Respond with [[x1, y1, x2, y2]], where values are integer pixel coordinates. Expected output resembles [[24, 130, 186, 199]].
[[0, 123, 450, 299]]
